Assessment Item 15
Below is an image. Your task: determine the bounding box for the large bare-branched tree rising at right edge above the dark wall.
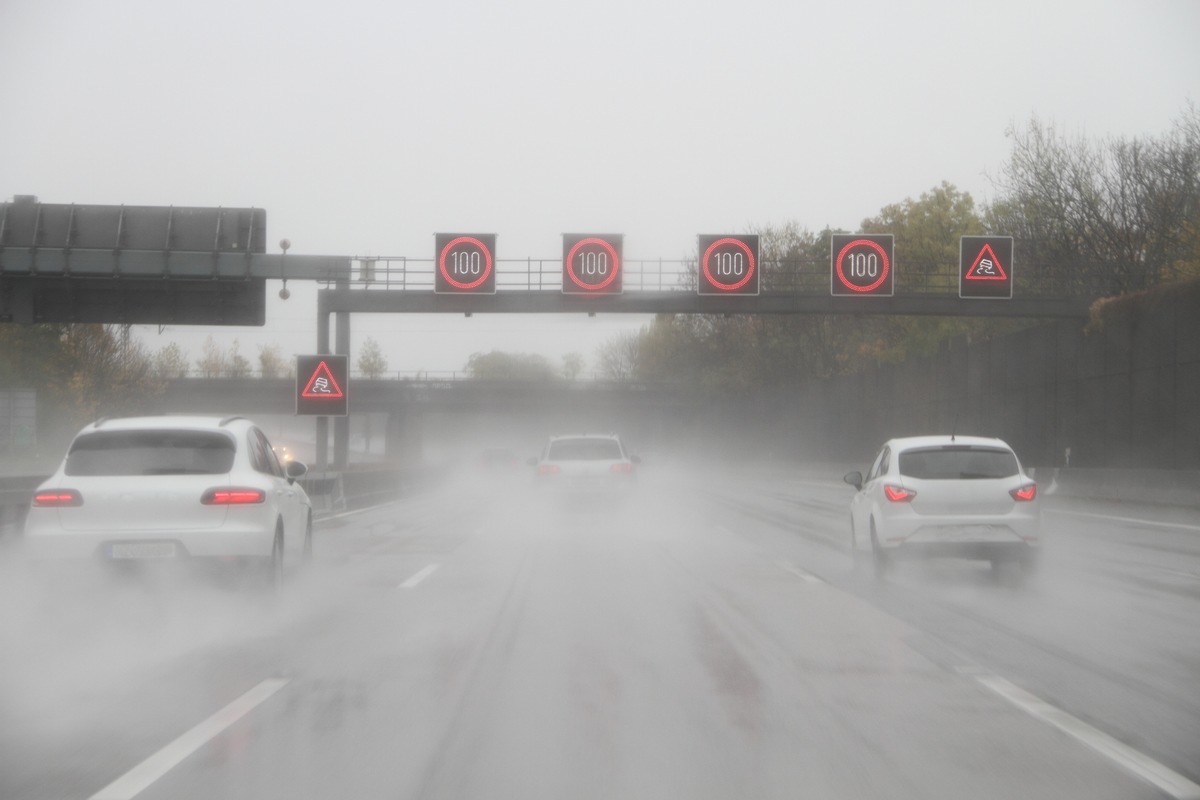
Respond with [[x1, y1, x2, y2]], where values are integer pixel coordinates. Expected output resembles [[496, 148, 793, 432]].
[[988, 107, 1200, 294]]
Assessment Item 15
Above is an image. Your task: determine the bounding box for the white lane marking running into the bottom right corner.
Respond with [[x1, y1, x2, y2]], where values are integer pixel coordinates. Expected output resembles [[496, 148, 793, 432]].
[[973, 674, 1200, 800]]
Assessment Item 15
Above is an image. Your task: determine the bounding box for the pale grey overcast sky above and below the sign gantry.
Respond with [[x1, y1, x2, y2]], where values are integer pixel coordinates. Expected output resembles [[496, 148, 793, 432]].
[[0, 0, 1200, 371]]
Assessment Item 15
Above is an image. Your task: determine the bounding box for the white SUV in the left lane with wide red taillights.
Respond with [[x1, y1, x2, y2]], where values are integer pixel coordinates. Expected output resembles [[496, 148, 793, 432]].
[[24, 416, 312, 585]]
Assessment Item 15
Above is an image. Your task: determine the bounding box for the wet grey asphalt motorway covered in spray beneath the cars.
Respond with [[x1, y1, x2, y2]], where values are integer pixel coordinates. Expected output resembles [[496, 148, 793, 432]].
[[0, 467, 1200, 800]]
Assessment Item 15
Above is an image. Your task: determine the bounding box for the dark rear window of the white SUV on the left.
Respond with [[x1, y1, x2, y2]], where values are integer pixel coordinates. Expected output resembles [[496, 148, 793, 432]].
[[66, 431, 235, 476]]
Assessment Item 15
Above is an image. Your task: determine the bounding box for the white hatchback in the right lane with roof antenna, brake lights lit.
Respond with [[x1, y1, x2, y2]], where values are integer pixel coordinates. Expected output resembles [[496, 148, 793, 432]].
[[845, 435, 1042, 576]]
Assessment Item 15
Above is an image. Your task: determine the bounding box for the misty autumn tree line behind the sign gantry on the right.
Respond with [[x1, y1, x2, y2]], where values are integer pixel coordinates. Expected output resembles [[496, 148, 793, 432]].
[[585, 106, 1200, 395]]
